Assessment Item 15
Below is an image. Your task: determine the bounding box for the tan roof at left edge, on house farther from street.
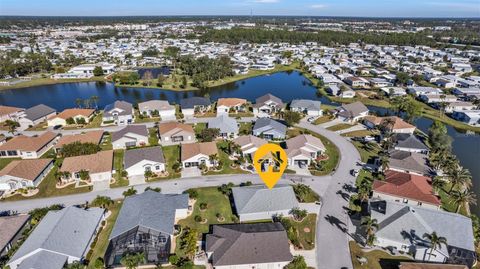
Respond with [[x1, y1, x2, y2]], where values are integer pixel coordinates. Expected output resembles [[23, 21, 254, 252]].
[[0, 132, 57, 151]]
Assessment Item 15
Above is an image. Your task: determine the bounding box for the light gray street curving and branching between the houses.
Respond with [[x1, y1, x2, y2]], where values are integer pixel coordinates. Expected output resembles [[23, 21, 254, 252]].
[[0, 121, 361, 269]]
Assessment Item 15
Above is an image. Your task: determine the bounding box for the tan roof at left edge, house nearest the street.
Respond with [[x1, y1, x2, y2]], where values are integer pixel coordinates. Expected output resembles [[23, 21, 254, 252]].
[[0, 159, 53, 180]]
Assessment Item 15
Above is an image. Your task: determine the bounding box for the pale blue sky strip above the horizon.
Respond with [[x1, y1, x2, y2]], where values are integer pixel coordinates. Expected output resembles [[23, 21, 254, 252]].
[[0, 0, 480, 18]]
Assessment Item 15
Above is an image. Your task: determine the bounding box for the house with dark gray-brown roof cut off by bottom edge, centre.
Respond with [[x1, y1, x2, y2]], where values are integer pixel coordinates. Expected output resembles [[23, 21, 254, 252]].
[[205, 222, 293, 269]]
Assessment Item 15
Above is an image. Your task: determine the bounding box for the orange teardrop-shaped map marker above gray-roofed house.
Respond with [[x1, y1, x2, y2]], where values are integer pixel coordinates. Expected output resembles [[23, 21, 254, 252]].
[[253, 144, 287, 189]]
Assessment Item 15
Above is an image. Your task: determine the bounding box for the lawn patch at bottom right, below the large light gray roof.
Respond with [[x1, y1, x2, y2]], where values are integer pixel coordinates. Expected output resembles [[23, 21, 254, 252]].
[[349, 241, 411, 269]]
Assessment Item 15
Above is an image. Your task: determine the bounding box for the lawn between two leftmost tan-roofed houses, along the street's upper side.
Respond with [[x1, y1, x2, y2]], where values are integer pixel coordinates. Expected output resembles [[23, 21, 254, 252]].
[[5, 166, 91, 201]]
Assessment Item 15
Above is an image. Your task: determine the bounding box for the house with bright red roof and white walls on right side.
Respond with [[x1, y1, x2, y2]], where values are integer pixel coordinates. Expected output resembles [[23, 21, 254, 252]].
[[372, 170, 442, 209]]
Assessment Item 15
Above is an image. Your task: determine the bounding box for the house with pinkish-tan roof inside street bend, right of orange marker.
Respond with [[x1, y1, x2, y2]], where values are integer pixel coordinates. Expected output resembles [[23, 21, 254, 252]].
[[285, 134, 327, 168]]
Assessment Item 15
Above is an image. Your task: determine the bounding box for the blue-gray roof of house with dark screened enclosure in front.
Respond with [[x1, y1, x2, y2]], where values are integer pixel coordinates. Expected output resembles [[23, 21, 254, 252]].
[[110, 191, 188, 240]]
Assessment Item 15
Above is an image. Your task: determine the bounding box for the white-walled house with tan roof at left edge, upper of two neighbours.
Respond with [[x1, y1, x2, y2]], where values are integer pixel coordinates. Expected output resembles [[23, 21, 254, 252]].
[[0, 132, 57, 159]]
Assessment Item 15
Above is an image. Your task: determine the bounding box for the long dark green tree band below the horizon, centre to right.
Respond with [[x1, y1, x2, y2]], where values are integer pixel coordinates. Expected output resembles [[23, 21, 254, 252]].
[[201, 28, 435, 46]]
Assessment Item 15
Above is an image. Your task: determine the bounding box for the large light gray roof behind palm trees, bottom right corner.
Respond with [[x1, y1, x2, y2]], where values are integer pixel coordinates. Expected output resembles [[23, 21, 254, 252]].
[[372, 201, 475, 251]]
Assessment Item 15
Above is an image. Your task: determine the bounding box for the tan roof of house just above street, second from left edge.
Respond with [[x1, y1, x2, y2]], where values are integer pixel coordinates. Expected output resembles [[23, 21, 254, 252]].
[[60, 150, 113, 174]]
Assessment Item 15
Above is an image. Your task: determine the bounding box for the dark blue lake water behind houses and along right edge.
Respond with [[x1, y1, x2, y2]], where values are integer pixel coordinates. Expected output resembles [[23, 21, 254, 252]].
[[0, 72, 480, 215]]
